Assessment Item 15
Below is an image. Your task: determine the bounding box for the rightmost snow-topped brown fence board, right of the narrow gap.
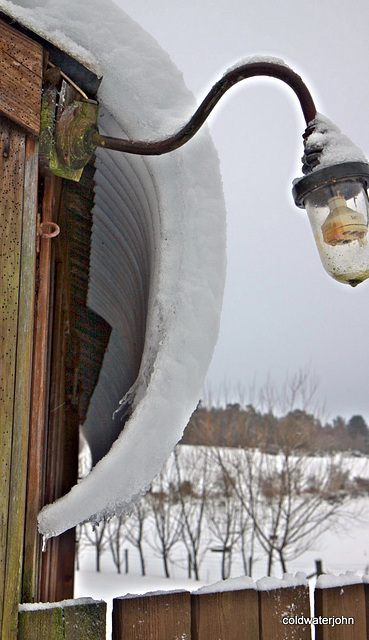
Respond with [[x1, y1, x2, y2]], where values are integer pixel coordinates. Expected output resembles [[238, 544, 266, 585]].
[[315, 574, 367, 640]]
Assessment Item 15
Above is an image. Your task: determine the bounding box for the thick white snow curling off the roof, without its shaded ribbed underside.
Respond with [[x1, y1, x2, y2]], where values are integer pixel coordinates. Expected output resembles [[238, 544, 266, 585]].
[[0, 0, 225, 539]]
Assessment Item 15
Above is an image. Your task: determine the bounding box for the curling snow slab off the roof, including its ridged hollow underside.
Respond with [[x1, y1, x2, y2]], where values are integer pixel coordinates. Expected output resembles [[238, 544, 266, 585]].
[[0, 0, 225, 537]]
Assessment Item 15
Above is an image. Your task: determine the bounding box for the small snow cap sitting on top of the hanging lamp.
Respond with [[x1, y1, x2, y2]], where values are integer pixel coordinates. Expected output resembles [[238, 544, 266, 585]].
[[306, 113, 368, 171]]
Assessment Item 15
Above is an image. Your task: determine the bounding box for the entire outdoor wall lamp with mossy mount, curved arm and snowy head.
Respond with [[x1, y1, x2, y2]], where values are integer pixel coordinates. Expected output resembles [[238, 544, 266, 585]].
[[41, 58, 369, 286]]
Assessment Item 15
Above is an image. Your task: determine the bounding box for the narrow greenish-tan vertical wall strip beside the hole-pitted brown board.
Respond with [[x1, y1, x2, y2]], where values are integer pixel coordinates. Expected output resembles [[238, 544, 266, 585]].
[[3, 138, 38, 637]]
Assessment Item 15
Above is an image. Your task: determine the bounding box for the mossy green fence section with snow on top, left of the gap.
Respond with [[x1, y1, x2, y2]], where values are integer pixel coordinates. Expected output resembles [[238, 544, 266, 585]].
[[18, 598, 106, 640]]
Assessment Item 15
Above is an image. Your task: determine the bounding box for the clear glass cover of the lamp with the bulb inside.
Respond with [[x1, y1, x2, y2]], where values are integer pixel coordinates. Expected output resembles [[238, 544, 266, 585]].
[[304, 179, 369, 287]]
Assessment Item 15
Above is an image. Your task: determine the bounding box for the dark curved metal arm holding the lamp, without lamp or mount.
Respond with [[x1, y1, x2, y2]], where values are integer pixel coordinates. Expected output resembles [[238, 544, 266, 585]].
[[91, 60, 316, 156]]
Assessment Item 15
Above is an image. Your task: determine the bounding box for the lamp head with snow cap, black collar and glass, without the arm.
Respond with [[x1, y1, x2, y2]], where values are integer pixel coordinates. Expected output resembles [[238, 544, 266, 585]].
[[293, 114, 369, 287]]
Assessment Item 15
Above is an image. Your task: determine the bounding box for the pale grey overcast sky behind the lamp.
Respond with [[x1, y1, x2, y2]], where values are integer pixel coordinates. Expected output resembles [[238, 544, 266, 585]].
[[115, 0, 369, 422]]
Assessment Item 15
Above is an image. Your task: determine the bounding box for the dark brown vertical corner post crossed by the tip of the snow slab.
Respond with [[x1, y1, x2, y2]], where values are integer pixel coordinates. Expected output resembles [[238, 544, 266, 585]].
[[40, 84, 81, 602]]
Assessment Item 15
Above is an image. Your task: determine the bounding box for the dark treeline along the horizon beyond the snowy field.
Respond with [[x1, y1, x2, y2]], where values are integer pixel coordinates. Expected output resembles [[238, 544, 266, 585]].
[[181, 403, 369, 455]]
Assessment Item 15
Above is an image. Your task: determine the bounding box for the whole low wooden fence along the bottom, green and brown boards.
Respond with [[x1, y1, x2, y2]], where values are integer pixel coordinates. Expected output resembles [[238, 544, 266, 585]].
[[18, 581, 369, 640]]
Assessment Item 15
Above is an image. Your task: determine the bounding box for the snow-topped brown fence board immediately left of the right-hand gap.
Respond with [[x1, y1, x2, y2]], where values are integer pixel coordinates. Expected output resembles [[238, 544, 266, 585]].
[[256, 576, 311, 640]]
